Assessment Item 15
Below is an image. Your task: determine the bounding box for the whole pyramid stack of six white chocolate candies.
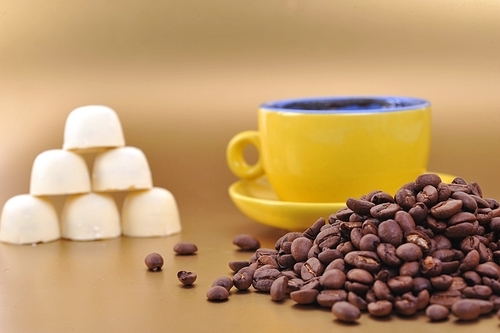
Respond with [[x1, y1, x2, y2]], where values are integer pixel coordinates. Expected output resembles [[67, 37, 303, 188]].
[[0, 105, 181, 244]]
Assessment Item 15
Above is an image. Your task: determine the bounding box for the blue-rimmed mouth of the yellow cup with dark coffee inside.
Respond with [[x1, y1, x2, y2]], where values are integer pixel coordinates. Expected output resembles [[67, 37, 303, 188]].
[[260, 96, 430, 114]]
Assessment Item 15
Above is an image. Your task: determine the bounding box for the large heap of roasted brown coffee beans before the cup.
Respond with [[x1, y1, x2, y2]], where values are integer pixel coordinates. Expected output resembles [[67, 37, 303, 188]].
[[223, 174, 500, 322]]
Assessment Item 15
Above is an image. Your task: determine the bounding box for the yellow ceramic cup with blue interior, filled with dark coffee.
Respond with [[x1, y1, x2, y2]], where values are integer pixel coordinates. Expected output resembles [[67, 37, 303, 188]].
[[226, 96, 431, 203]]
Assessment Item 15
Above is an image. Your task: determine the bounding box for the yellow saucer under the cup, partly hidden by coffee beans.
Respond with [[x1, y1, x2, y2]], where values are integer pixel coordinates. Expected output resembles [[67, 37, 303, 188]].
[[229, 173, 455, 231]]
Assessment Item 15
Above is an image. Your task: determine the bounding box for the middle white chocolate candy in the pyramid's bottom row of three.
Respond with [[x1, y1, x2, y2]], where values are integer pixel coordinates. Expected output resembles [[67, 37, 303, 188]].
[[61, 192, 121, 241]]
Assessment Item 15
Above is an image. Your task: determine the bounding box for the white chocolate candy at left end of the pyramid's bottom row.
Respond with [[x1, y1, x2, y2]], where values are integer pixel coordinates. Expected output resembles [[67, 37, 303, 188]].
[[0, 194, 60, 244]]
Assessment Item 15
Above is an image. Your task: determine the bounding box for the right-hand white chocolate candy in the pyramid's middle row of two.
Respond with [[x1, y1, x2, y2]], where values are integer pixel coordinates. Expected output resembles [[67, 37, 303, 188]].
[[92, 147, 153, 192]]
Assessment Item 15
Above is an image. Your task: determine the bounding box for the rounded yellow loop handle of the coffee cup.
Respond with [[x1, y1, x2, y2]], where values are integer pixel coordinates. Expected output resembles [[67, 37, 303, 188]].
[[226, 131, 264, 180]]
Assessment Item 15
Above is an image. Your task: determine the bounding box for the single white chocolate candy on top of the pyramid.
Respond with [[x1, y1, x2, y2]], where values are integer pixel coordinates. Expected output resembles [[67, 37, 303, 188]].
[[63, 105, 125, 152]]
